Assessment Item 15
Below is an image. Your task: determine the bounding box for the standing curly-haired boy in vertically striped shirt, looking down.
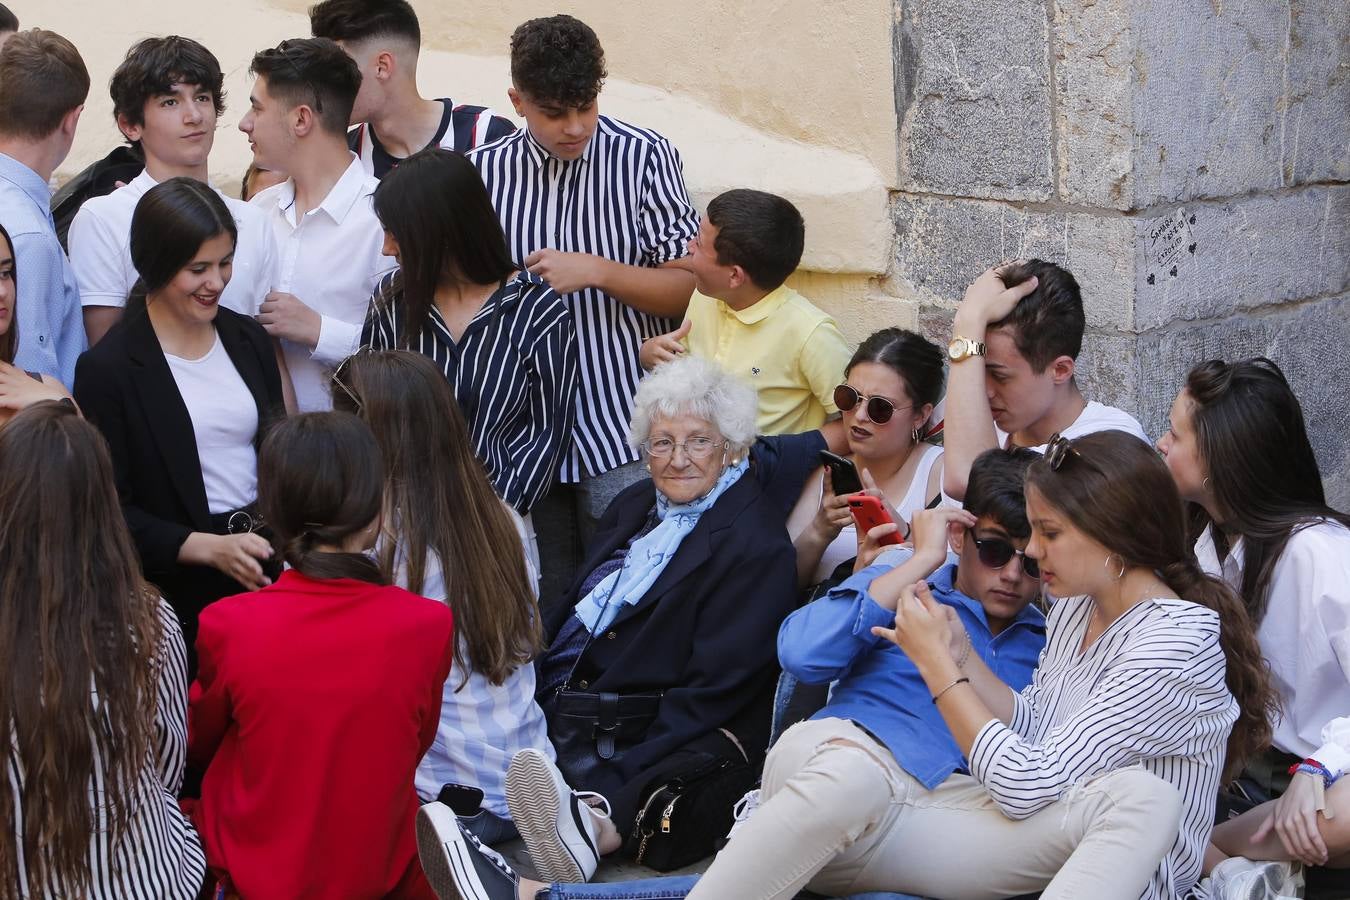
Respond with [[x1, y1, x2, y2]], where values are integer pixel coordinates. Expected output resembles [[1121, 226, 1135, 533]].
[[468, 15, 698, 598]]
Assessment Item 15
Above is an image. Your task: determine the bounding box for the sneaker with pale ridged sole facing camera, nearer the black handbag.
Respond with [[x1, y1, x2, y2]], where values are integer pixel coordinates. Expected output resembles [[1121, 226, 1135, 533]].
[[506, 749, 609, 884]]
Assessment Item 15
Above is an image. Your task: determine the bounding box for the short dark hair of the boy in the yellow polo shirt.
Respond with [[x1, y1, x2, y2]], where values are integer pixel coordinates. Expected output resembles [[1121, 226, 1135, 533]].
[[707, 188, 806, 290]]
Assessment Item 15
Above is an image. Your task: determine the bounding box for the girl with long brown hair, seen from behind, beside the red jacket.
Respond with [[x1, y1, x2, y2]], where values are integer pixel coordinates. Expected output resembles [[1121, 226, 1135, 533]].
[[333, 351, 542, 843]]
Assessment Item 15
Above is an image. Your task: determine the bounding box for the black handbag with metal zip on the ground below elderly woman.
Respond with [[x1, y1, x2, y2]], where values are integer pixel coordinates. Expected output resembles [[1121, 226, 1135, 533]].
[[624, 753, 759, 872]]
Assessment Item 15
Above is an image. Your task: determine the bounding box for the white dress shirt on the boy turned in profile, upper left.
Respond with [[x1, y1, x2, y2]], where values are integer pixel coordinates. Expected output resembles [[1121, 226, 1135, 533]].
[[250, 154, 397, 413]]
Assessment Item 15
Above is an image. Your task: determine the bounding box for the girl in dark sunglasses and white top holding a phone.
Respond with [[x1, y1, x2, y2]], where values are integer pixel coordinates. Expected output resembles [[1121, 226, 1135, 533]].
[[787, 328, 944, 587]]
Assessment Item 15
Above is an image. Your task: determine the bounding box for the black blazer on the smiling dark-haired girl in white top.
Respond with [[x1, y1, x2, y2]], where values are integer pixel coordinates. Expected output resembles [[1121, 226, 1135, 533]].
[[74, 306, 285, 585]]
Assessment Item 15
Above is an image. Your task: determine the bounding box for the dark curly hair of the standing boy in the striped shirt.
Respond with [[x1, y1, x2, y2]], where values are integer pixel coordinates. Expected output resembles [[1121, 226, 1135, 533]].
[[510, 15, 608, 108]]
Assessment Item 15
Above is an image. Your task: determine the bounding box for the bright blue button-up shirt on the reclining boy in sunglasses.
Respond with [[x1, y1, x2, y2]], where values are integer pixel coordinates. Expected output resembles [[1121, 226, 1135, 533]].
[[778, 553, 1045, 791]]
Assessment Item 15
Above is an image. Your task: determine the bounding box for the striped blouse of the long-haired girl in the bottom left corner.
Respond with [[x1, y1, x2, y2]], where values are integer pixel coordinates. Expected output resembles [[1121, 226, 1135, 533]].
[[9, 600, 207, 900]]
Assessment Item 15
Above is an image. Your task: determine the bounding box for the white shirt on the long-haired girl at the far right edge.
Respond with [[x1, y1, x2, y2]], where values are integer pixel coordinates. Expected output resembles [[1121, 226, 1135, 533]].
[[1195, 521, 1350, 765]]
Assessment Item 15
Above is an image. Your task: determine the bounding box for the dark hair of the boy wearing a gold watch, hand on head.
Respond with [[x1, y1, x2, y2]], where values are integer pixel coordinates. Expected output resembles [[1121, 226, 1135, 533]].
[[990, 259, 1085, 372]]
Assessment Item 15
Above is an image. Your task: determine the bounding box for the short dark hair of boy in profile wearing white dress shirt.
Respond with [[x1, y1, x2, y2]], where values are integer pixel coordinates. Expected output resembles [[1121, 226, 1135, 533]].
[[248, 38, 360, 136]]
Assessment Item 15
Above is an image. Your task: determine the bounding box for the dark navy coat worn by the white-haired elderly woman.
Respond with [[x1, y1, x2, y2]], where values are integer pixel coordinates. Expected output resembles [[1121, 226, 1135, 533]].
[[544, 472, 797, 831]]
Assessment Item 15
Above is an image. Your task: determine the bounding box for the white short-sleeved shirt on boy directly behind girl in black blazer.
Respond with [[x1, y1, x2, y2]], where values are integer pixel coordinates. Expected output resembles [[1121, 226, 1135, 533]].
[[68, 171, 275, 316]]
